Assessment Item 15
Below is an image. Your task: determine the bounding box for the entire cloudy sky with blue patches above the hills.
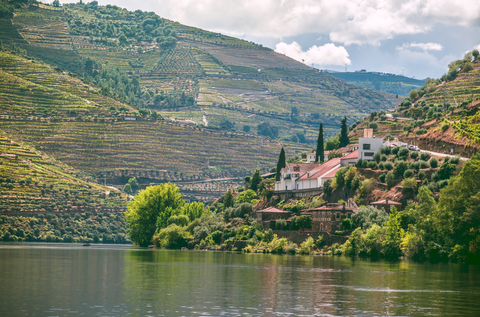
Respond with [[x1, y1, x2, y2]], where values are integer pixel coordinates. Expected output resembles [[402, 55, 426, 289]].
[[58, 0, 480, 79]]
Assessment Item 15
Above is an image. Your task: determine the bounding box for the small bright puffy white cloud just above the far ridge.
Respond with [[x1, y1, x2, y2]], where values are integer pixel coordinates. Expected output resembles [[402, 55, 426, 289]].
[[275, 42, 352, 66]]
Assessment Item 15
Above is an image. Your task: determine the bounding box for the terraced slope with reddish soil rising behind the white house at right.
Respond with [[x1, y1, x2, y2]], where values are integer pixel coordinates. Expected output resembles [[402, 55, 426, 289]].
[[350, 54, 480, 157]]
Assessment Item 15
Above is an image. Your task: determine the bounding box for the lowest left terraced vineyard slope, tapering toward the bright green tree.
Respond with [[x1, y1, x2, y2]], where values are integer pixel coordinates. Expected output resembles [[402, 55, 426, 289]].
[[0, 134, 126, 216]]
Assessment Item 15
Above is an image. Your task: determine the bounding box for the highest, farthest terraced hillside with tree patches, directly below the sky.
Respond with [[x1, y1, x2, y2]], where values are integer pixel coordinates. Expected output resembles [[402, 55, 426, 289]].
[[0, 2, 396, 146]]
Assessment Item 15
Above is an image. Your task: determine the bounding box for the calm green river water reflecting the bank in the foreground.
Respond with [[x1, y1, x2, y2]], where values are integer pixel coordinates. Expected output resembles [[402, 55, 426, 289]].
[[0, 243, 480, 316]]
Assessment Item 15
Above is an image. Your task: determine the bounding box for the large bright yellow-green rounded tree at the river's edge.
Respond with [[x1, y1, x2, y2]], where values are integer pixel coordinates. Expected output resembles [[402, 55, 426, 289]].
[[125, 183, 184, 247]]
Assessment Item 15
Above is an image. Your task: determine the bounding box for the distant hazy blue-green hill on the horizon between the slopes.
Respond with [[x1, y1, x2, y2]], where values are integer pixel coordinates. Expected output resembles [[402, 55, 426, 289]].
[[326, 71, 425, 96]]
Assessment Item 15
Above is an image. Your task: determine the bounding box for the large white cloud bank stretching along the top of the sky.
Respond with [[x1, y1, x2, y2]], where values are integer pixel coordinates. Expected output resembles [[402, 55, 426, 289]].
[[145, 0, 480, 45]]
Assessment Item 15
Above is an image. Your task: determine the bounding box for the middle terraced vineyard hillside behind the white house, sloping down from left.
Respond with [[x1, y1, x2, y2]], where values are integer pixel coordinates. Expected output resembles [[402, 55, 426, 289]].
[[0, 48, 307, 197]]
